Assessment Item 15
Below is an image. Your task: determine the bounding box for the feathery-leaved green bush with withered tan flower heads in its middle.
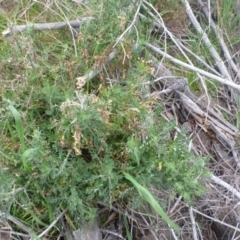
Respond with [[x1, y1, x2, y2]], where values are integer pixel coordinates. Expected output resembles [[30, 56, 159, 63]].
[[2, 80, 208, 231]]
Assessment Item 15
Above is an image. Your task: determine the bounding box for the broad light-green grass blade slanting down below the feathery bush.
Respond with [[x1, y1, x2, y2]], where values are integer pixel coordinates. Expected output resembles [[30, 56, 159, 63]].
[[123, 173, 180, 233]]
